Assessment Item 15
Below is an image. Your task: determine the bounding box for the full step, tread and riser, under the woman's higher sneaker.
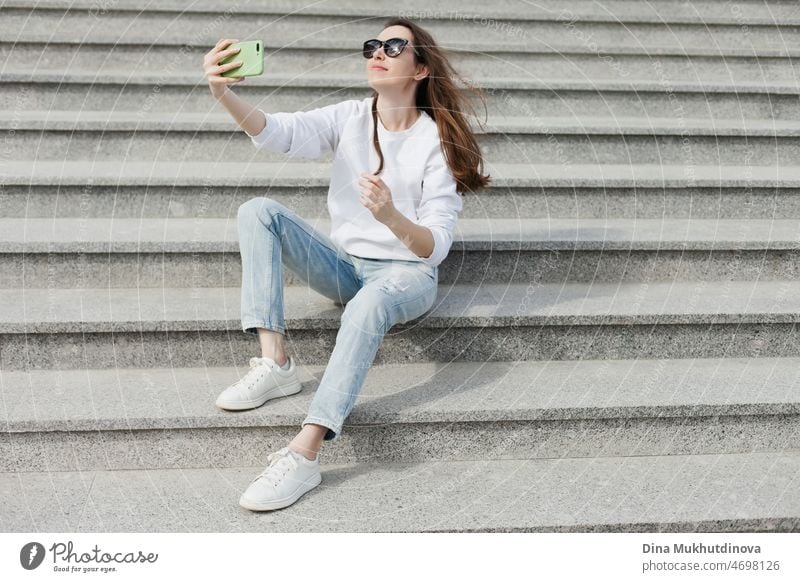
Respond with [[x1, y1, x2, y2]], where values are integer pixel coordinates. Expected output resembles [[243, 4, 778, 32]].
[[0, 357, 800, 472]]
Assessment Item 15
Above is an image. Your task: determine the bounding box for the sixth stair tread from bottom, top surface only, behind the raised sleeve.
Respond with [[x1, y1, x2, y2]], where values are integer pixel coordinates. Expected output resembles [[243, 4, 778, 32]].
[[7, 110, 800, 137]]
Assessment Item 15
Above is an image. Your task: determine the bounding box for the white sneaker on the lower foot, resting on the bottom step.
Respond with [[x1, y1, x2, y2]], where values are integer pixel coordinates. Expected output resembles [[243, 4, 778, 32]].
[[239, 446, 322, 511]]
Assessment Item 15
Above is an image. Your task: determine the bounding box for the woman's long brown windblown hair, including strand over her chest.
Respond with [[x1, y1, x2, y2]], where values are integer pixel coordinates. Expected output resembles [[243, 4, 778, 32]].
[[372, 18, 491, 194]]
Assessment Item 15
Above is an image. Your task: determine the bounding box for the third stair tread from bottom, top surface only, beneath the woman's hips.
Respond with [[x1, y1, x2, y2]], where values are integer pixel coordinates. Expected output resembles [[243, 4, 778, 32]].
[[0, 280, 800, 334]]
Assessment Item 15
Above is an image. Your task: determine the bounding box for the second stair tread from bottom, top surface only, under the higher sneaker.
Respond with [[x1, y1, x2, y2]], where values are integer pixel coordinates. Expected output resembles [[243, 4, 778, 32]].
[[0, 357, 800, 432]]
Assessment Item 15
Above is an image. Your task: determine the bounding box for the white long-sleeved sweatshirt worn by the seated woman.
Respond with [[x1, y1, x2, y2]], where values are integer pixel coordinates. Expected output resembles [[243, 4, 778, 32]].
[[248, 97, 463, 267]]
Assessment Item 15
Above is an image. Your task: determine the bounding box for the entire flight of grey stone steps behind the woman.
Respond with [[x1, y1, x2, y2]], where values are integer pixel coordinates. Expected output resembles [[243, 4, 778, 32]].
[[0, 0, 800, 531]]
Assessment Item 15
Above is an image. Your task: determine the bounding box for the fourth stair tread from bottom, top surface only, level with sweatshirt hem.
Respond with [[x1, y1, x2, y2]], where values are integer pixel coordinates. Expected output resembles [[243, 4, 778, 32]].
[[0, 217, 800, 253]]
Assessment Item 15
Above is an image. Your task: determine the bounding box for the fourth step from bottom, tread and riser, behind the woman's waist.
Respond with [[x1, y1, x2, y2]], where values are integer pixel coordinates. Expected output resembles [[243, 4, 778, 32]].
[[0, 216, 800, 290]]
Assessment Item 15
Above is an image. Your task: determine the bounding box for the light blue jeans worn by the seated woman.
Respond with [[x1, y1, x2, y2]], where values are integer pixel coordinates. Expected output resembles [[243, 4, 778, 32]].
[[238, 197, 439, 441]]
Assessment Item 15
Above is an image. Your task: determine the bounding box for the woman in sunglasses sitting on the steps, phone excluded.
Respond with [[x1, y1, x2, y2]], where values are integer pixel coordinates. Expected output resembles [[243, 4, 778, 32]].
[[204, 18, 490, 510]]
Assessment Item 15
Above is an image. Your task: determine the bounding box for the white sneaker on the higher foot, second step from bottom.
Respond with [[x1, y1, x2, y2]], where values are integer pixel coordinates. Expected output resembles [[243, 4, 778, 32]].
[[217, 357, 302, 410]]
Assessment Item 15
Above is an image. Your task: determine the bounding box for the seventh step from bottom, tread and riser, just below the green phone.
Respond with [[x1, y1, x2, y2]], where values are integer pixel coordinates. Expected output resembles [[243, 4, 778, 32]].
[[0, 68, 800, 120]]
